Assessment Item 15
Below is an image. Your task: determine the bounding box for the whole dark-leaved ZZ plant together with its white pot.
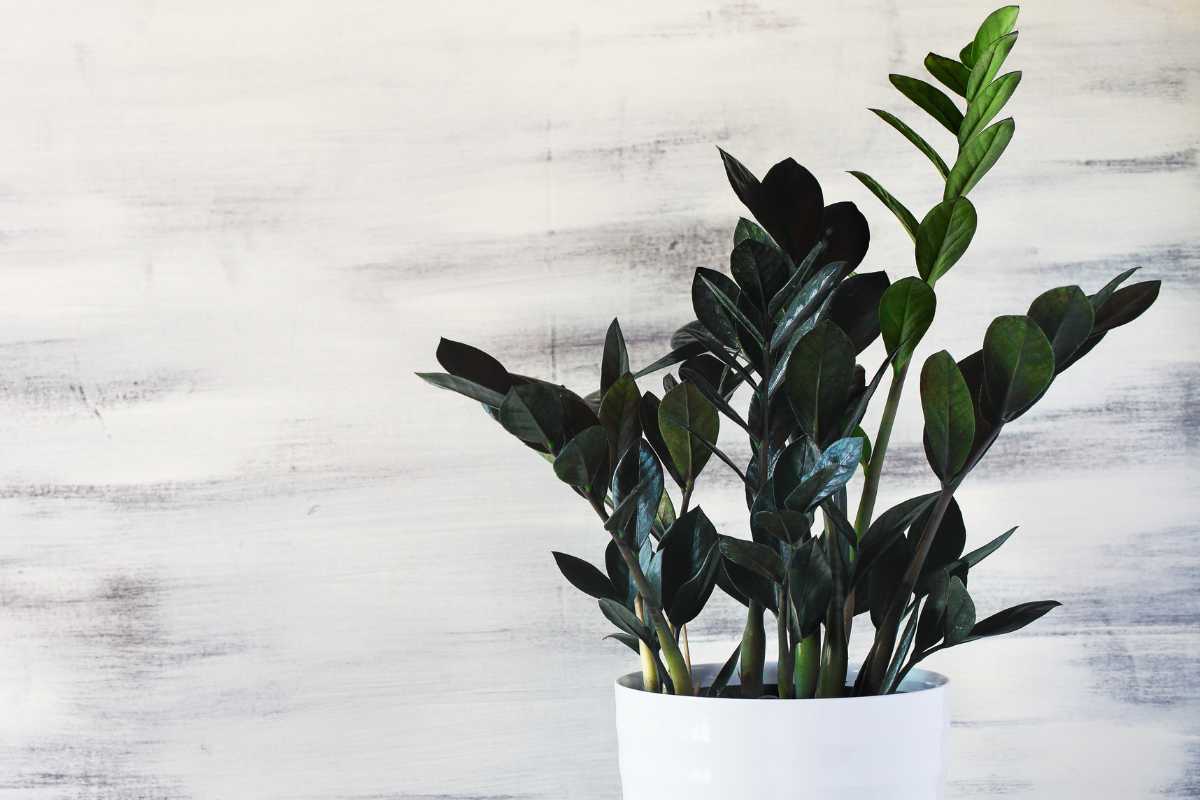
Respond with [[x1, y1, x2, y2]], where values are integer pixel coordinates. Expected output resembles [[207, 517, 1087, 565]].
[[421, 6, 1159, 800]]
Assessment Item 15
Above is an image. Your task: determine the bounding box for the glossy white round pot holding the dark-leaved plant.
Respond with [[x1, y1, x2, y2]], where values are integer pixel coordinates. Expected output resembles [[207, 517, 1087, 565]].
[[617, 664, 949, 800]]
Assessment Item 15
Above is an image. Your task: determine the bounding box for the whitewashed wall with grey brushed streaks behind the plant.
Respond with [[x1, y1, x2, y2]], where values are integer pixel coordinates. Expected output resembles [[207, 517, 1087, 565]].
[[0, 0, 1200, 800]]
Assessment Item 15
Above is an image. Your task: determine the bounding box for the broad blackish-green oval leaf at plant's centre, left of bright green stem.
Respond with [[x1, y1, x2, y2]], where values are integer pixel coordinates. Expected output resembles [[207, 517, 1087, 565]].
[[785, 321, 854, 443]]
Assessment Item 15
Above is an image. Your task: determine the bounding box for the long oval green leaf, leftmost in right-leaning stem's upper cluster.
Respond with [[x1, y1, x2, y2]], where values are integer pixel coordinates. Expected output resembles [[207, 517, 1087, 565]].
[[920, 350, 974, 481]]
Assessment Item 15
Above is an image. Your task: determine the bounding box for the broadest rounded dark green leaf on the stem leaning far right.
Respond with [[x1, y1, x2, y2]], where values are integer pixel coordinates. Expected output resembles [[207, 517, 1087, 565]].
[[983, 315, 1055, 422]]
